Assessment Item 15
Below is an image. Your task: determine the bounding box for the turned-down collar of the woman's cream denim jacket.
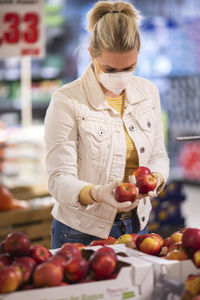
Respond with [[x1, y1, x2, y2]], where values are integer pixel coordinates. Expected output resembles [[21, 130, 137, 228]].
[[81, 62, 147, 110]]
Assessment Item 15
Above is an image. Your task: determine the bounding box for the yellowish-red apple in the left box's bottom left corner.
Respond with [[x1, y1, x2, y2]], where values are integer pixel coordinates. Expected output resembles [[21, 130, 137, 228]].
[[0, 266, 19, 294]]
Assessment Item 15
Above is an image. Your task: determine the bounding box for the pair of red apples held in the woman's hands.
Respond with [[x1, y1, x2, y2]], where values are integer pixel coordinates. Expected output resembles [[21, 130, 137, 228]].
[[115, 166, 157, 202]]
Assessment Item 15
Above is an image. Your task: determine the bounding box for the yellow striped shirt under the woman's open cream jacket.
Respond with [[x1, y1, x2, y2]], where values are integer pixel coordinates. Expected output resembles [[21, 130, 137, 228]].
[[106, 93, 138, 182]]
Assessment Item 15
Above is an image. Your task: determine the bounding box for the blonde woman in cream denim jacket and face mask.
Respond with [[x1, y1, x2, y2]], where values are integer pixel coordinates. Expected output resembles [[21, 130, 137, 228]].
[[45, 1, 169, 248]]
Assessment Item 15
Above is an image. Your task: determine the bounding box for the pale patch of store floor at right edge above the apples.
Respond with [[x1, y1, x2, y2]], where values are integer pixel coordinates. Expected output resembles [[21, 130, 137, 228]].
[[182, 184, 200, 228]]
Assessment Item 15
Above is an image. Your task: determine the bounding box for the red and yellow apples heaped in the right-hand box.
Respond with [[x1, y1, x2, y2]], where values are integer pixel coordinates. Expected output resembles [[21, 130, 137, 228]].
[[104, 228, 200, 268]]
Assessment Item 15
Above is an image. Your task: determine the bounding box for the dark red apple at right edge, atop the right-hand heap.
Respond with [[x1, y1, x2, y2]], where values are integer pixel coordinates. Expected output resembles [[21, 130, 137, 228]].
[[182, 228, 200, 256]]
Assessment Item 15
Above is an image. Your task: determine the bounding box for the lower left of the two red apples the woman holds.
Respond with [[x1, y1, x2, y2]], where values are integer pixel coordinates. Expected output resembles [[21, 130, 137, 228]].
[[115, 182, 138, 202]]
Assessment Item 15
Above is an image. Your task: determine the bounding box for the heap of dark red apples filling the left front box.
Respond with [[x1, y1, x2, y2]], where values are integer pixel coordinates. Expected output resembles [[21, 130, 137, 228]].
[[0, 232, 119, 294]]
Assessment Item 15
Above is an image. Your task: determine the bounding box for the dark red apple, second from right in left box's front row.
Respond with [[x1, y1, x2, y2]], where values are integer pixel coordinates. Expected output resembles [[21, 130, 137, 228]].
[[64, 257, 89, 282]]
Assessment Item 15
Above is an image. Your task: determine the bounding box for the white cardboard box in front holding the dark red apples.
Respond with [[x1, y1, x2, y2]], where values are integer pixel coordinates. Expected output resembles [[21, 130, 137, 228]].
[[0, 247, 154, 300]]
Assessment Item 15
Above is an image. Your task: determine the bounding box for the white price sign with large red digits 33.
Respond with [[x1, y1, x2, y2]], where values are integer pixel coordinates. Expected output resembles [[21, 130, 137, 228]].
[[0, 0, 44, 58]]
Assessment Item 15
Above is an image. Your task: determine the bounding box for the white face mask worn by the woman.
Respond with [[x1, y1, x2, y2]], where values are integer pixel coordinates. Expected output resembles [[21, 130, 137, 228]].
[[95, 60, 133, 95]]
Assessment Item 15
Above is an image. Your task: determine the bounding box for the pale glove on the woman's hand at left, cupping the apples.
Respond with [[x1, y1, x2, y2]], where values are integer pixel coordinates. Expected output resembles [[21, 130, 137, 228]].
[[90, 180, 132, 209]]
